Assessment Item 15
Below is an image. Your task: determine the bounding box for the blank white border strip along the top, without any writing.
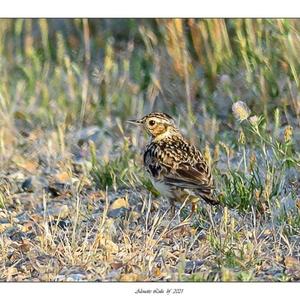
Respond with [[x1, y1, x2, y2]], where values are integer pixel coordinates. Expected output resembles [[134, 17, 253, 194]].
[[0, 0, 300, 18]]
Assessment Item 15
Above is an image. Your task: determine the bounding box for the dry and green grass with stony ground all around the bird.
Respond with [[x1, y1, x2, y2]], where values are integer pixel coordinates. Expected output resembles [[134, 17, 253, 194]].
[[0, 19, 300, 281]]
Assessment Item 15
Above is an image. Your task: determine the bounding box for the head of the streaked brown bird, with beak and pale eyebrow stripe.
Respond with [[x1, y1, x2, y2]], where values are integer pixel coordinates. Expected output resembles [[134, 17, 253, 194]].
[[128, 112, 179, 138]]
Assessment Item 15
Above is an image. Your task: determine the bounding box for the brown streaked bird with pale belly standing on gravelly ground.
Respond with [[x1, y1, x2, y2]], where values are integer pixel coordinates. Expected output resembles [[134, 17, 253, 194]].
[[128, 112, 219, 216]]
